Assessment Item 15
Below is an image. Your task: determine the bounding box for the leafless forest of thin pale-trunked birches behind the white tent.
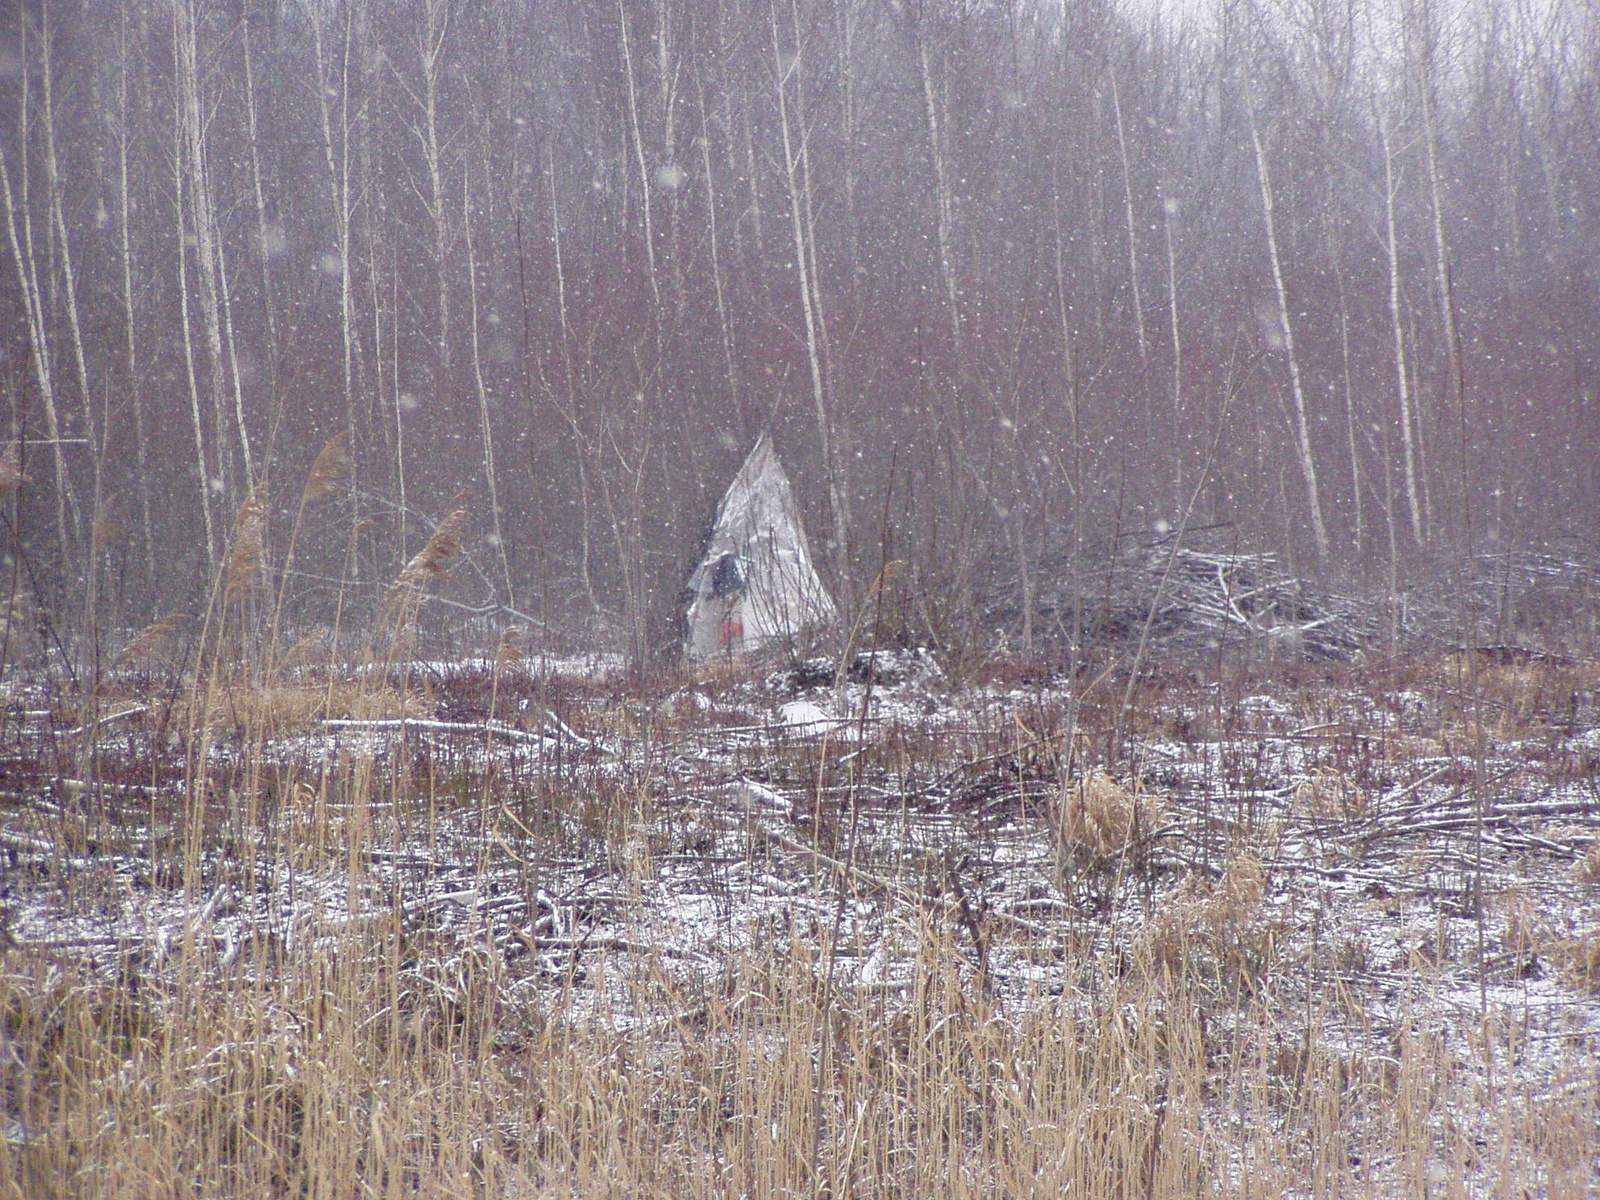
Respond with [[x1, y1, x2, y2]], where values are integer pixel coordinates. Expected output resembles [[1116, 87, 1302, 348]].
[[0, 0, 1600, 650]]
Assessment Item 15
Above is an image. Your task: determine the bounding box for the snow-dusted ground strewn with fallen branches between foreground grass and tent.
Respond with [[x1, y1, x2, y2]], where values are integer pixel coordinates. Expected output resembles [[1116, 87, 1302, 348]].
[[0, 643, 1600, 1190]]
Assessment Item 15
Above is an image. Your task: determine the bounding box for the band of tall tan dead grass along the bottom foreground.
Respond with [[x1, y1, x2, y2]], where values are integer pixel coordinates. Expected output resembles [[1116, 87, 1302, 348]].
[[0, 864, 1597, 1200]]
